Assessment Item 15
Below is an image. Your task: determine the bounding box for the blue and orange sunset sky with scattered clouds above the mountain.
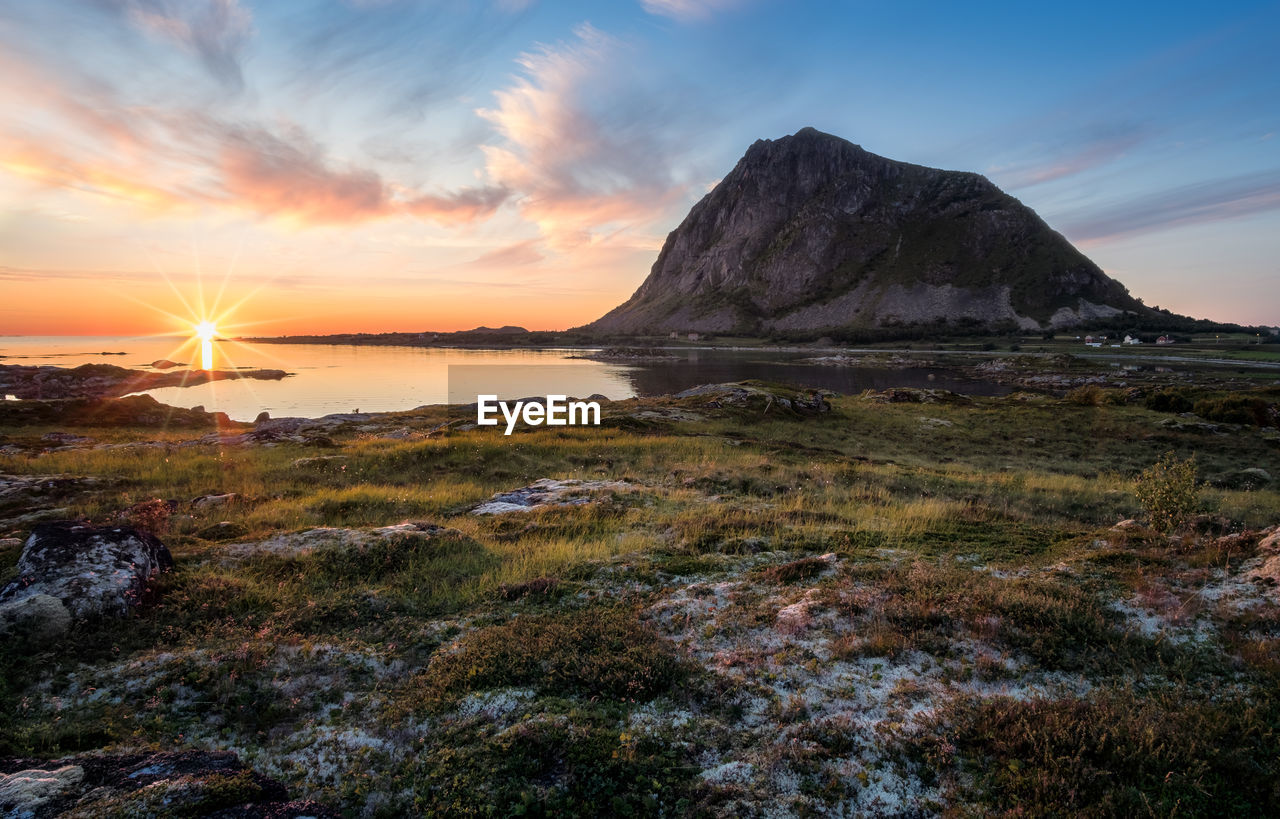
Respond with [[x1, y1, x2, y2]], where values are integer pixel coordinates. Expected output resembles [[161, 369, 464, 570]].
[[0, 0, 1280, 335]]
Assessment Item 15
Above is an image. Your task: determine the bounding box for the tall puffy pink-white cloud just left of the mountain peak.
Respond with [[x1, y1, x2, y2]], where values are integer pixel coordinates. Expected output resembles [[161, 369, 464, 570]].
[[477, 24, 687, 248]]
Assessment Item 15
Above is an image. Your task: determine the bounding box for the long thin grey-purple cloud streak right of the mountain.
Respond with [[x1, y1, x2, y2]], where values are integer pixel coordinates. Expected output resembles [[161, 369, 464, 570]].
[[1064, 170, 1280, 242]]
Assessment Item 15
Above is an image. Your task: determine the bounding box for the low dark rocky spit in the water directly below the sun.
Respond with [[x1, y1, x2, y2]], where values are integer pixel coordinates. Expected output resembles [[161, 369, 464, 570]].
[[0, 363, 289, 399]]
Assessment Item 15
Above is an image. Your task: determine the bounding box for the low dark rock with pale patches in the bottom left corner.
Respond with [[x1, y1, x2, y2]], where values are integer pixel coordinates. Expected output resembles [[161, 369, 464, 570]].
[[0, 751, 339, 819]]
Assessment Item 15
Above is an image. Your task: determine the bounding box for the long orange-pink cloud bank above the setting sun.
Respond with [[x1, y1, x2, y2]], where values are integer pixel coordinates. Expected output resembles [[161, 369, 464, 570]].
[[0, 55, 507, 225]]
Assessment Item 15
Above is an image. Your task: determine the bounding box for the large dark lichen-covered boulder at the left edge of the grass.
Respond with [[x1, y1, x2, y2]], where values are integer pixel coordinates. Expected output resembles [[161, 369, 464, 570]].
[[0, 522, 173, 637]]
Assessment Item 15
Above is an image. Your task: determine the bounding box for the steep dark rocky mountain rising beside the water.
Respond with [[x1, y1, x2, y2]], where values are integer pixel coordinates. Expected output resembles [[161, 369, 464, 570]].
[[586, 128, 1147, 334]]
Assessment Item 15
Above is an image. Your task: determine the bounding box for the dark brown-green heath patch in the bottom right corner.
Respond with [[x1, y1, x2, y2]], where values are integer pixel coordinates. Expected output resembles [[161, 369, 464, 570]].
[[909, 690, 1280, 816]]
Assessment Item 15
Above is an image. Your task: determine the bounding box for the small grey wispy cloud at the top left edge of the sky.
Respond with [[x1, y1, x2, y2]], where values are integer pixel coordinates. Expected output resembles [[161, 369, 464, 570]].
[[99, 0, 253, 88]]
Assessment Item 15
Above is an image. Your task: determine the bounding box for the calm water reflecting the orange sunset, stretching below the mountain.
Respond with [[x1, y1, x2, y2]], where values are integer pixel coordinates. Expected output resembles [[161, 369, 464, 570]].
[[0, 337, 1007, 420]]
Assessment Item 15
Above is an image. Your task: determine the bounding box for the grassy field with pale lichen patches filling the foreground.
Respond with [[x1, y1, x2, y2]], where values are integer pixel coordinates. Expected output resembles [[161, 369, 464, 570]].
[[0, 388, 1280, 815]]
